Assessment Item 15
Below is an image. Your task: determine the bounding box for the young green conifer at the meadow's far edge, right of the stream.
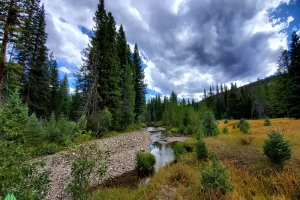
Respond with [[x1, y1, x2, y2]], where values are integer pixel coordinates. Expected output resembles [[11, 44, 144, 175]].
[[202, 111, 220, 136]]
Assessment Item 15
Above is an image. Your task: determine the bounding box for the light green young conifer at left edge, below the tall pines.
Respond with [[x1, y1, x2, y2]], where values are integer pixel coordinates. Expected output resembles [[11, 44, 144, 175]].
[[0, 91, 29, 141]]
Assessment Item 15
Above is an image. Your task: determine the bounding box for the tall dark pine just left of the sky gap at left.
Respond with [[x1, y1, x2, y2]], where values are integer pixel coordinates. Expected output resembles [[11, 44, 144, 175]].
[[24, 6, 49, 117]]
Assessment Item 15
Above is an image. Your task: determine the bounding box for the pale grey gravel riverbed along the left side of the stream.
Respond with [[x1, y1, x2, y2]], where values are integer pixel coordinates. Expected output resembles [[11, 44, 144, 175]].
[[42, 131, 150, 200]]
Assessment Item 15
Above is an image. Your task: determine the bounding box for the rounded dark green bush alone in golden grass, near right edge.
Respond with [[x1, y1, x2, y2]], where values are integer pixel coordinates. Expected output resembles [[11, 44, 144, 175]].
[[263, 131, 292, 166]]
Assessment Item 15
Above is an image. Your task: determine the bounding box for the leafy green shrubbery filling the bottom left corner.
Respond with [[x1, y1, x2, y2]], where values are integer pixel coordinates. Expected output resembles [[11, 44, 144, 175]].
[[0, 142, 50, 199]]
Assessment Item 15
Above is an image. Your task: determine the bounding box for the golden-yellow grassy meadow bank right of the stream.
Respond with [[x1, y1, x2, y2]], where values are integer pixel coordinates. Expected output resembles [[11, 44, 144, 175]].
[[90, 119, 300, 200]]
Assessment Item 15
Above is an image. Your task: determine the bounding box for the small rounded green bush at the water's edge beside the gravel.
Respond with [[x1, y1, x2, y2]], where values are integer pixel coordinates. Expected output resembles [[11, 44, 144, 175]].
[[137, 152, 156, 172]]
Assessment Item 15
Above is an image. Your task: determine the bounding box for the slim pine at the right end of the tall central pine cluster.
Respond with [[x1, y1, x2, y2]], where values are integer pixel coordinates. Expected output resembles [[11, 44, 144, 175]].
[[133, 44, 146, 120]]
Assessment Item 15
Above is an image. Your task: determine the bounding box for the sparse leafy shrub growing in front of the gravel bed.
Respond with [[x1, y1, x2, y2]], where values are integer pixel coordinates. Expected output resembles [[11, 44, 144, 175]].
[[66, 144, 108, 200]]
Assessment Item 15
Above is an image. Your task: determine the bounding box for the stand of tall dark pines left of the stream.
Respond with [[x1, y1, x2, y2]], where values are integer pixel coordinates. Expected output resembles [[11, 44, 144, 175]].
[[0, 0, 146, 135]]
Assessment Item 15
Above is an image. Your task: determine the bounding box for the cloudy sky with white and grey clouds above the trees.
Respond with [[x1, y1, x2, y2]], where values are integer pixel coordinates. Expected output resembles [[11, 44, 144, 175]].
[[43, 0, 300, 100]]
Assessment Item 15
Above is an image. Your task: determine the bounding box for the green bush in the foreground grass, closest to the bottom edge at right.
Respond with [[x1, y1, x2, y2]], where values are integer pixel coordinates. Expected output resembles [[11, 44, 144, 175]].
[[201, 159, 233, 195]]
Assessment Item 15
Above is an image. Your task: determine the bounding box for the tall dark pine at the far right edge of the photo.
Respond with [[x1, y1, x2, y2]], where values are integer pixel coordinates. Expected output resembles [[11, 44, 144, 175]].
[[286, 32, 300, 119]]
